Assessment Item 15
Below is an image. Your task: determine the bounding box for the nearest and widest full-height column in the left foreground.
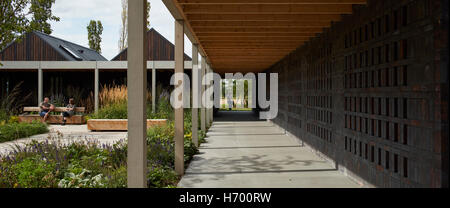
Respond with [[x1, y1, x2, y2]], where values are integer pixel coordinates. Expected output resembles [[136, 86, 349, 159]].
[[127, 0, 147, 188]]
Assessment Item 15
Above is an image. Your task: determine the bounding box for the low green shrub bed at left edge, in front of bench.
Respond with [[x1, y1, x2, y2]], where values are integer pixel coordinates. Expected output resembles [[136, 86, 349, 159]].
[[0, 122, 48, 142]]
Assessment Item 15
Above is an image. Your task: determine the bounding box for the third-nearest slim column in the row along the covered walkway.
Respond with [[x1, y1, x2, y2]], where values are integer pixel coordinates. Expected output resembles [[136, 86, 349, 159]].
[[192, 44, 200, 147]]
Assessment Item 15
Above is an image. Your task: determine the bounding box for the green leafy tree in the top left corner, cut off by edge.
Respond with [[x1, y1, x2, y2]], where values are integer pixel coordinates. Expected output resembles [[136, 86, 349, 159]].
[[0, 0, 28, 50]]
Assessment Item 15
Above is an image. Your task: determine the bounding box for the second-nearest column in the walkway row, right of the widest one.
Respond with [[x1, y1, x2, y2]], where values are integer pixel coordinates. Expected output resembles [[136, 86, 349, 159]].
[[174, 20, 184, 175]]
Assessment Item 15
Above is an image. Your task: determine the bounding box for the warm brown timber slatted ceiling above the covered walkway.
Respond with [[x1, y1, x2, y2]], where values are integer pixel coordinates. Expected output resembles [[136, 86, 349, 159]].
[[173, 0, 366, 73]]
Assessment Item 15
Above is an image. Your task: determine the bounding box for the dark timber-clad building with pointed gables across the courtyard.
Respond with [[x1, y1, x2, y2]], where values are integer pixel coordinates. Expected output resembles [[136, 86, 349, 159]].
[[0, 28, 190, 108]]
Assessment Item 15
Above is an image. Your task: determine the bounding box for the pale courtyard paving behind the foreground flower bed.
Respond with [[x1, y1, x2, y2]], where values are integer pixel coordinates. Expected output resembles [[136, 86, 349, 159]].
[[0, 125, 127, 155]]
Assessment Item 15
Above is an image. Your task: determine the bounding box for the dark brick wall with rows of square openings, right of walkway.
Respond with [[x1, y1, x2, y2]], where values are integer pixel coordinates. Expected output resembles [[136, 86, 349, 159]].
[[267, 0, 448, 187]]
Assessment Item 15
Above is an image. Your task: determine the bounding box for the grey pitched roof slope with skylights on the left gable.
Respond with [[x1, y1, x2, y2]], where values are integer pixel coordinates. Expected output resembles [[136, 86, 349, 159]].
[[32, 31, 107, 61]]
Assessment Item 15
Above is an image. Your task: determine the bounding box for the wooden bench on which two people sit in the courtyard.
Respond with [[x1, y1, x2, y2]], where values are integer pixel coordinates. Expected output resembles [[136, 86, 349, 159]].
[[19, 107, 86, 124]]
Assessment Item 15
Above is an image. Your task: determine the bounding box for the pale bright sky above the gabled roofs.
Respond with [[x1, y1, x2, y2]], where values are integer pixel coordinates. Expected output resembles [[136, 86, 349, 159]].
[[51, 0, 192, 60]]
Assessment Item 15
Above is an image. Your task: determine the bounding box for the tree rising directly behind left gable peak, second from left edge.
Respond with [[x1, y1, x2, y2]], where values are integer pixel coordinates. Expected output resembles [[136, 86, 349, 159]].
[[27, 0, 60, 34]]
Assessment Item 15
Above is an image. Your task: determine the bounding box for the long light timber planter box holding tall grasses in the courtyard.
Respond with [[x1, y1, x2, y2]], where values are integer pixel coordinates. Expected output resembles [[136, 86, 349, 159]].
[[87, 119, 167, 131]]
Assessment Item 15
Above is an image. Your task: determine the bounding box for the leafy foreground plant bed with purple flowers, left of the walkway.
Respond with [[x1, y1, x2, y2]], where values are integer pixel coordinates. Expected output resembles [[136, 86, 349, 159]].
[[0, 120, 205, 188]]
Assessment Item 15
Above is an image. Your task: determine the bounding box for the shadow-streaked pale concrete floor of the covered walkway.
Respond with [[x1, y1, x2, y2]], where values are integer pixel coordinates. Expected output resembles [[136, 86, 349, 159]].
[[178, 113, 360, 188]]
